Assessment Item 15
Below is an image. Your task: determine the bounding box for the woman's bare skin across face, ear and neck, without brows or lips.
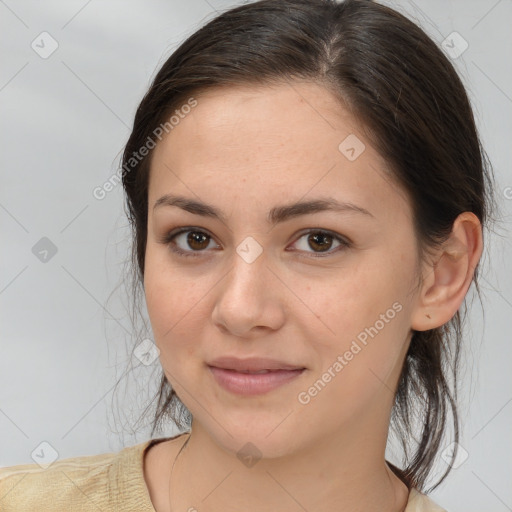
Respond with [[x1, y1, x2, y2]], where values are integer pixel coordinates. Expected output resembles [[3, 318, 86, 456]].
[[144, 82, 482, 512]]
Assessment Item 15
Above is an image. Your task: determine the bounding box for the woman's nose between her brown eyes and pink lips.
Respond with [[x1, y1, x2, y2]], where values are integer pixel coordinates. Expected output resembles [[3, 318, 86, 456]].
[[212, 252, 289, 338]]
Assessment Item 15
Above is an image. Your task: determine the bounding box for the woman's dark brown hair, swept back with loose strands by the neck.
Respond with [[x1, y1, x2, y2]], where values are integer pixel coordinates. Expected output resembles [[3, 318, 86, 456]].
[[122, 0, 493, 492]]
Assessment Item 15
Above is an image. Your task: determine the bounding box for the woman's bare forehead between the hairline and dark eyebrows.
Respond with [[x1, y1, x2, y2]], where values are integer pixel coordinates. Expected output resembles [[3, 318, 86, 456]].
[[149, 82, 408, 224]]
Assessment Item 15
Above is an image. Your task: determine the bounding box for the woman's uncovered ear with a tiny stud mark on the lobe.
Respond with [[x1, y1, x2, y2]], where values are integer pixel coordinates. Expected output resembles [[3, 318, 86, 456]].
[[411, 212, 483, 331]]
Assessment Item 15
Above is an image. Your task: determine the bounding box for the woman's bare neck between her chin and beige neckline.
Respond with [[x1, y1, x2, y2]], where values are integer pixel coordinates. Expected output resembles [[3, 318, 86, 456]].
[[170, 394, 408, 512]]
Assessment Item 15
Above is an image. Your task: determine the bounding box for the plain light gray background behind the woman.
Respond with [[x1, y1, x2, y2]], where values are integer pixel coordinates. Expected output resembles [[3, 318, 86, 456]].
[[0, 0, 512, 512]]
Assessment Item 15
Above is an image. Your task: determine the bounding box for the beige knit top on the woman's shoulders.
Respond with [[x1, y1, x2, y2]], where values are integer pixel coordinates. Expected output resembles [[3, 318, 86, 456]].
[[0, 436, 447, 512]]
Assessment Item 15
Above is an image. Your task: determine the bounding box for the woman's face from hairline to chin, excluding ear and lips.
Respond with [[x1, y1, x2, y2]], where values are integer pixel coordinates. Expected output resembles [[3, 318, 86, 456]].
[[144, 82, 417, 456]]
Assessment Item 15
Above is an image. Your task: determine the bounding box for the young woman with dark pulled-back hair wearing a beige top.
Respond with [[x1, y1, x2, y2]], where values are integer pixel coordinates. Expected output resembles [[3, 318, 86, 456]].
[[0, 0, 496, 512]]
